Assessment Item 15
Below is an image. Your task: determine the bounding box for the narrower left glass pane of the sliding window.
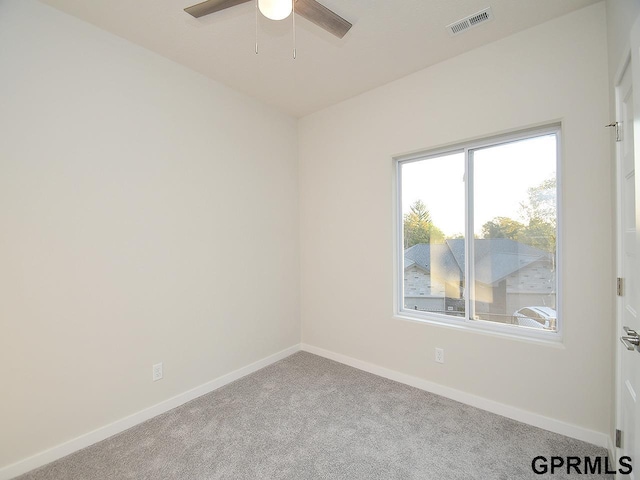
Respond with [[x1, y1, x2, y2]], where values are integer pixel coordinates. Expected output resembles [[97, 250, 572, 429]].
[[400, 152, 465, 317]]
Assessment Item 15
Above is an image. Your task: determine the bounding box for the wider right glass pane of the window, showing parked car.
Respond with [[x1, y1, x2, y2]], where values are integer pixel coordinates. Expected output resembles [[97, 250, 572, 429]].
[[469, 134, 557, 330]]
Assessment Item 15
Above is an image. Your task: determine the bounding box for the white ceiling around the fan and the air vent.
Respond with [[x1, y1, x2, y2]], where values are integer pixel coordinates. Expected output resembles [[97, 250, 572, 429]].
[[40, 0, 600, 116]]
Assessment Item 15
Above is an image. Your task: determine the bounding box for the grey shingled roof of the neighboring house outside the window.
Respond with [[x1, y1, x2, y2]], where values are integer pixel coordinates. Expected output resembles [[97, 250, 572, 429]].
[[404, 238, 552, 285]]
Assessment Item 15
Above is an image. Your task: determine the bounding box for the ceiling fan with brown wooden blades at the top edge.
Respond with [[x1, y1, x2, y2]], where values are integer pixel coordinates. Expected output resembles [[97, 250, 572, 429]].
[[184, 0, 352, 38]]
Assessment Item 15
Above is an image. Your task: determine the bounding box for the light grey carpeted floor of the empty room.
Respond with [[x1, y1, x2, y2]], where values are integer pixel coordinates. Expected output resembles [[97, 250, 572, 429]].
[[19, 352, 613, 480]]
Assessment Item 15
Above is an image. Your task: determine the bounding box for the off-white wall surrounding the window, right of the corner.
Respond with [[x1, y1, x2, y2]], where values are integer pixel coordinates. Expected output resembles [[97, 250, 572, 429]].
[[299, 3, 613, 434]]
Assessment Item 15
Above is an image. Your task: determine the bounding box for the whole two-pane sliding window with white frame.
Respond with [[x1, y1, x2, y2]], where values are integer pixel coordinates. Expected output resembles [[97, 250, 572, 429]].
[[397, 126, 560, 338]]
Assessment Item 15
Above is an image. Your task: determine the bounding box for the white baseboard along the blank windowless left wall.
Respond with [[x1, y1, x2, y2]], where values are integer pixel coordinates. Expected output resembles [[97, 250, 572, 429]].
[[0, 345, 300, 480]]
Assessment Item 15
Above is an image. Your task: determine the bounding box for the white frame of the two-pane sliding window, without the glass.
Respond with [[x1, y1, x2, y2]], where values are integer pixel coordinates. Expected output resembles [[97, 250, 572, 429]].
[[393, 123, 563, 345]]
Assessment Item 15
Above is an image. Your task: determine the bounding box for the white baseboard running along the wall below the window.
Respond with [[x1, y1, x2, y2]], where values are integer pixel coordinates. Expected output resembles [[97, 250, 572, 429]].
[[302, 343, 611, 449]]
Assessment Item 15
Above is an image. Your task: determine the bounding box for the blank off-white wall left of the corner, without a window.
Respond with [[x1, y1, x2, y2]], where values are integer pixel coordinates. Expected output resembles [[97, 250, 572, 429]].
[[0, 0, 300, 467]]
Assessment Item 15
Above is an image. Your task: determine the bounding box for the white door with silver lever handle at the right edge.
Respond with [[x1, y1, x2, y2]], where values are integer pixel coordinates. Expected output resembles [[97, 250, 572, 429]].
[[616, 16, 640, 479]]
